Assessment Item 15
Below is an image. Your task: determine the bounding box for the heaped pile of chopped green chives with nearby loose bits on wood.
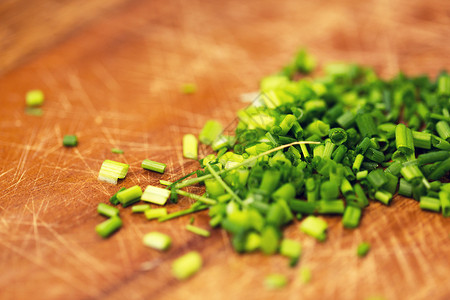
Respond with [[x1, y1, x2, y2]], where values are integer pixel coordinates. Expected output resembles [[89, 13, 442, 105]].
[[93, 51, 450, 282]]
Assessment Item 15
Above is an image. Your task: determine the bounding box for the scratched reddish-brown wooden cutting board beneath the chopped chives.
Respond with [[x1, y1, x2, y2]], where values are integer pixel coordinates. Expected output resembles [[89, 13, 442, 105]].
[[0, 0, 450, 299]]
